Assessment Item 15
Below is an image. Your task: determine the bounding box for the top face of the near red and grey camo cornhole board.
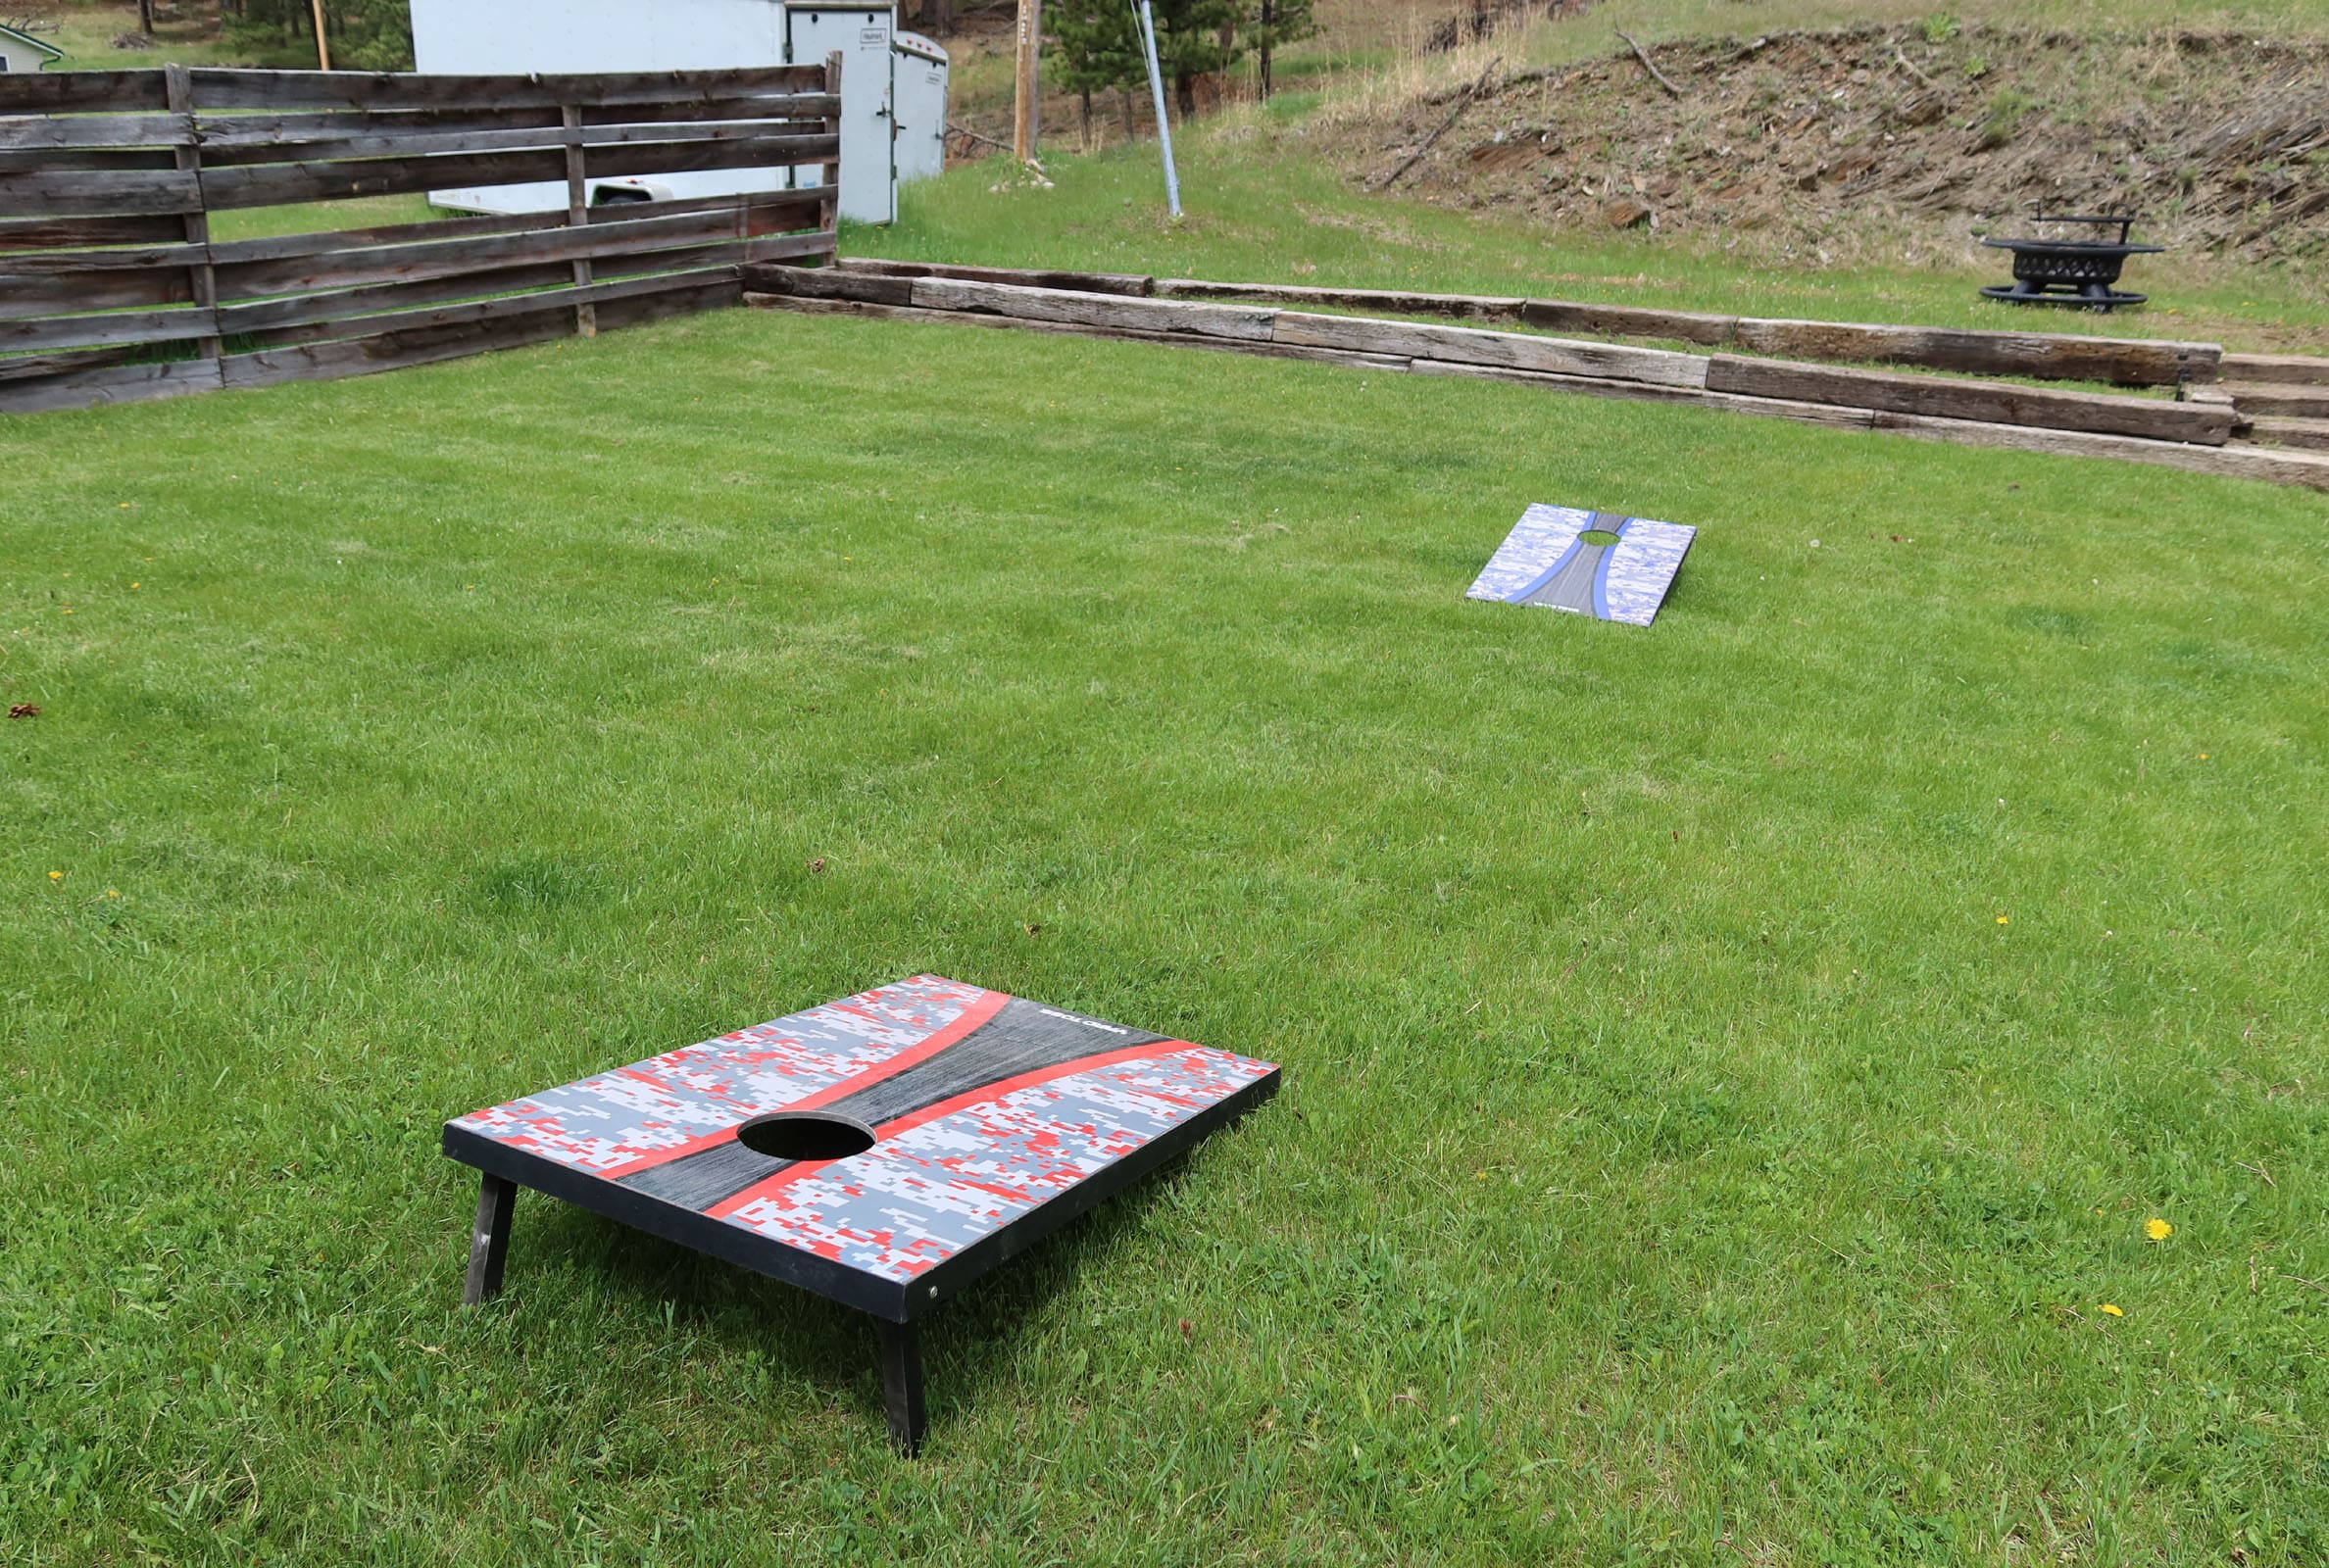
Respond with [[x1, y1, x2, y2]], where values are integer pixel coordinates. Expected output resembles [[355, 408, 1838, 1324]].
[[452, 974, 1276, 1284]]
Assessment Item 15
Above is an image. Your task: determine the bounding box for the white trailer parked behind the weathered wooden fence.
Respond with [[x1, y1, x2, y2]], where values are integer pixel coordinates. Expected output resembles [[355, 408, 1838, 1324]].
[[410, 0, 946, 223]]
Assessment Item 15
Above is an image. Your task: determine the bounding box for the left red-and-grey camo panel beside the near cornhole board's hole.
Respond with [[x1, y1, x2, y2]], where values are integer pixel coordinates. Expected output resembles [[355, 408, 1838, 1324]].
[[454, 974, 985, 1174]]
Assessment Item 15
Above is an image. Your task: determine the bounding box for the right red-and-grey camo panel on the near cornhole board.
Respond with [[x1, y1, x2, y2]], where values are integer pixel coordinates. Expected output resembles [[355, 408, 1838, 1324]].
[[729, 1044, 1271, 1282]]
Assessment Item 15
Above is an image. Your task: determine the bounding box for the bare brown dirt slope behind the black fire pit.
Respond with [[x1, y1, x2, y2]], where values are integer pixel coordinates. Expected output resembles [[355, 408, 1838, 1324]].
[[1353, 28, 2329, 270]]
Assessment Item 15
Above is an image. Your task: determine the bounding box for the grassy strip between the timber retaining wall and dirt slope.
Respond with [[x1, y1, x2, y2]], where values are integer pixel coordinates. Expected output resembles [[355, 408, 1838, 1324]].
[[843, 110, 2329, 350]]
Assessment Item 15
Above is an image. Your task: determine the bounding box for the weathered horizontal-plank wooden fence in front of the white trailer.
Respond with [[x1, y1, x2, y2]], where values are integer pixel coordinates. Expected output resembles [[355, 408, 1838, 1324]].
[[0, 56, 841, 410]]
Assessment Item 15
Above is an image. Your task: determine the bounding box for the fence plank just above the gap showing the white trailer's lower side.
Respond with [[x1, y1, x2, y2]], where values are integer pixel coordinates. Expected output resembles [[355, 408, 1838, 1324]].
[[197, 135, 841, 210]]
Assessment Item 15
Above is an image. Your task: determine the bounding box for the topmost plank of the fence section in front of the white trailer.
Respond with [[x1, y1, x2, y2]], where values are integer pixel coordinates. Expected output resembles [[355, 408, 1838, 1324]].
[[190, 66, 824, 110]]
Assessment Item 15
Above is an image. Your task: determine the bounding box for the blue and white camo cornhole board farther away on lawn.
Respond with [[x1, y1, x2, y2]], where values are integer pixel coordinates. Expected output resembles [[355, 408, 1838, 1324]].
[[1465, 506, 1698, 627]]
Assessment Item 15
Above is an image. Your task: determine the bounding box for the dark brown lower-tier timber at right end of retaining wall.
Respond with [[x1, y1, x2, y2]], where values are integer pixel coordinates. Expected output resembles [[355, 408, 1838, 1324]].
[[1708, 354, 2231, 447]]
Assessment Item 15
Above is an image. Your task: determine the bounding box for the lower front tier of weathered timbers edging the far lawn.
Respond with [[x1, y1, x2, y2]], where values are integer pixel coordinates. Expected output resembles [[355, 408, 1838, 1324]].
[[745, 261, 2329, 489]]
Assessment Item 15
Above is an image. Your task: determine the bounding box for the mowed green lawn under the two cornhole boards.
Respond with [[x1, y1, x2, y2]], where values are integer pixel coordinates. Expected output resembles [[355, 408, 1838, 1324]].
[[0, 310, 2329, 1566]]
